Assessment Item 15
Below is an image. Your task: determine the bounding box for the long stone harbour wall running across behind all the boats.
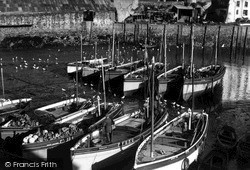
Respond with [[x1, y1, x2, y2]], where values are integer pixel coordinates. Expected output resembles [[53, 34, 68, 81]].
[[0, 11, 250, 51]]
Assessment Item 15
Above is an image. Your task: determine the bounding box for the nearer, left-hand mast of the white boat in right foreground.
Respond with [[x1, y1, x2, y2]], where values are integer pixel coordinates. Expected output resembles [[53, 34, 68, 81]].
[[150, 57, 155, 158]]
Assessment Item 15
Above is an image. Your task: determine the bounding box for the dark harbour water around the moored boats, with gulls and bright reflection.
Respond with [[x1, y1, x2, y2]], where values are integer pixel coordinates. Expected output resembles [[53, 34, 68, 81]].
[[0, 44, 250, 170]]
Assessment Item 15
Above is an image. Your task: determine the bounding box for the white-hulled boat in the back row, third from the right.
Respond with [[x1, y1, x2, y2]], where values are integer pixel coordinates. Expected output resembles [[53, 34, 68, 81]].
[[123, 62, 163, 96]]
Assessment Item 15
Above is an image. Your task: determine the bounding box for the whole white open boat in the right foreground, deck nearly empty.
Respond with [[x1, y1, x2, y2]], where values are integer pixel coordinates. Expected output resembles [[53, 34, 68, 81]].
[[134, 110, 208, 170]]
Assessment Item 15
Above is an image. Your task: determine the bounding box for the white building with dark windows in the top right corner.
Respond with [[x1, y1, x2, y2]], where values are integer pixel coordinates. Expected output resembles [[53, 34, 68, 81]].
[[226, 0, 250, 23]]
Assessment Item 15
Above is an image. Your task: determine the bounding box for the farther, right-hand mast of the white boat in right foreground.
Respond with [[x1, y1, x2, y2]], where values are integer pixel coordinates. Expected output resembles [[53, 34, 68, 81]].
[[188, 24, 194, 130]]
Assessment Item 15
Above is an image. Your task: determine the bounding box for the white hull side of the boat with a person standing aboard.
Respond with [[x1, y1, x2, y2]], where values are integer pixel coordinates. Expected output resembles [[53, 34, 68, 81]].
[[71, 109, 168, 170]]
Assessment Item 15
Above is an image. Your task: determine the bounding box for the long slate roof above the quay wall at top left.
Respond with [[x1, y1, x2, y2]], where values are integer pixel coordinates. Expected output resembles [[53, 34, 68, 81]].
[[0, 0, 115, 13]]
